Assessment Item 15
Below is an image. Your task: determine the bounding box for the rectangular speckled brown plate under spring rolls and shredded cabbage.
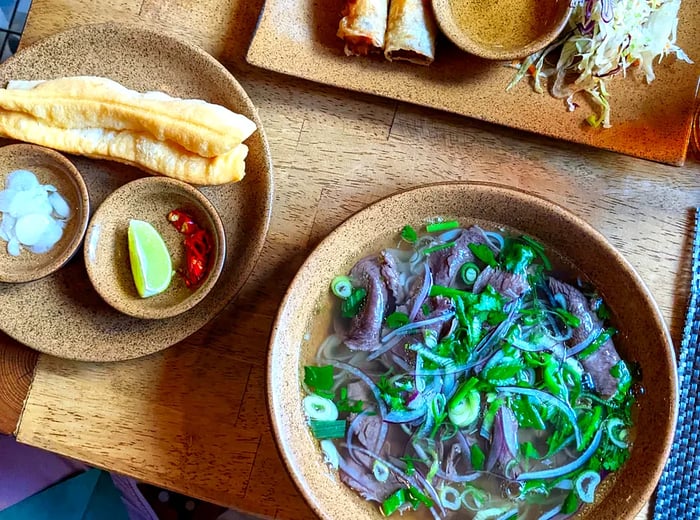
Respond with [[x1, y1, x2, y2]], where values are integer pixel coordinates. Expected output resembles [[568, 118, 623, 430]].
[[248, 0, 700, 164]]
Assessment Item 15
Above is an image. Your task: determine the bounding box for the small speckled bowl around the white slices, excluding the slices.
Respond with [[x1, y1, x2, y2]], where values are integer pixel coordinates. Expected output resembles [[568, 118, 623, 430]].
[[0, 144, 90, 283]]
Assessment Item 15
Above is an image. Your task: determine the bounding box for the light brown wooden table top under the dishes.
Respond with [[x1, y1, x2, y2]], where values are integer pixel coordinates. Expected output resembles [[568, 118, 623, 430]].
[[0, 0, 700, 519]]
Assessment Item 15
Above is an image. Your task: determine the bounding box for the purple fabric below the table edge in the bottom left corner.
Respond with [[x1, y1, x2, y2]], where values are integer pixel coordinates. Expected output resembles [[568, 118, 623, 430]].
[[0, 435, 158, 520]]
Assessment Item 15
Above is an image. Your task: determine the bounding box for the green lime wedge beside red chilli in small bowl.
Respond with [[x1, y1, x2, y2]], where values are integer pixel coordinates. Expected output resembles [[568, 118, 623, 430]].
[[129, 220, 173, 298]]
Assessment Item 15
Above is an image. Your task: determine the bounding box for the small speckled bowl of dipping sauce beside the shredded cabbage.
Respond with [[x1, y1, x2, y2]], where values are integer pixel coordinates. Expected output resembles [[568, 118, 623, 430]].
[[432, 0, 572, 60]]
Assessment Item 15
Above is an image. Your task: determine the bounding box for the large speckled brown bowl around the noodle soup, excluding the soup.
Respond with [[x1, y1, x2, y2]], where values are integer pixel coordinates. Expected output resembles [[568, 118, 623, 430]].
[[267, 183, 677, 520]]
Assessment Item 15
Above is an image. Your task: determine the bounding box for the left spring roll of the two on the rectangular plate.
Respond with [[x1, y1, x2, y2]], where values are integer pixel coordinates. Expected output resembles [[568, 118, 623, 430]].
[[337, 0, 389, 56]]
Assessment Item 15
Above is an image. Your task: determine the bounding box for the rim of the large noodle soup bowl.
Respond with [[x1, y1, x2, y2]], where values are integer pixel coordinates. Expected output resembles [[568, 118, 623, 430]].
[[266, 181, 679, 520]]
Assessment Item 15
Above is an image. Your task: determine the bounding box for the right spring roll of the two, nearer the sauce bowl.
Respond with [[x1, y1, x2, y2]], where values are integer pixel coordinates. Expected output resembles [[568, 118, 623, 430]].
[[384, 0, 437, 65]]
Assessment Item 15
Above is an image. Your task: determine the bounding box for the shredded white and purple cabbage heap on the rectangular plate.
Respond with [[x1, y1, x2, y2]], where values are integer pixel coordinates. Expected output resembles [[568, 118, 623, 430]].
[[506, 0, 692, 128]]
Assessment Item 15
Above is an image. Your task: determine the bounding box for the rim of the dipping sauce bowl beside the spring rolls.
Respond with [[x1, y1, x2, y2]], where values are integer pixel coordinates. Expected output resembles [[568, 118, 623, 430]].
[[431, 0, 574, 61]]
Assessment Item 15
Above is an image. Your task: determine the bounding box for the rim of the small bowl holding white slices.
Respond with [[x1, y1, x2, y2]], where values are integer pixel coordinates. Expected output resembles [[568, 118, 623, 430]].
[[0, 143, 90, 283]]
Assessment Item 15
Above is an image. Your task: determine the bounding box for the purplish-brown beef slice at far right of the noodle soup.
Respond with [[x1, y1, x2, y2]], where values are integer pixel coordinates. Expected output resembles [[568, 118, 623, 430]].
[[549, 278, 620, 398]]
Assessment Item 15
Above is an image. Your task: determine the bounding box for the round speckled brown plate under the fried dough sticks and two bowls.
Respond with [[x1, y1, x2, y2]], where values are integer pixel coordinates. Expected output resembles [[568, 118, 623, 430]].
[[0, 24, 272, 361]]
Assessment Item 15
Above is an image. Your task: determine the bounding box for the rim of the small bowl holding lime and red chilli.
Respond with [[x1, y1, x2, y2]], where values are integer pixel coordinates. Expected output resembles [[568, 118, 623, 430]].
[[83, 175, 226, 320]]
